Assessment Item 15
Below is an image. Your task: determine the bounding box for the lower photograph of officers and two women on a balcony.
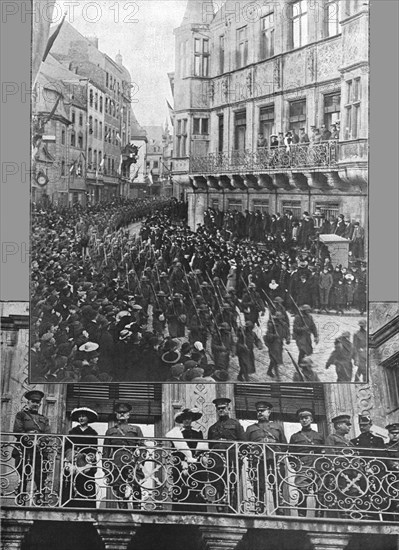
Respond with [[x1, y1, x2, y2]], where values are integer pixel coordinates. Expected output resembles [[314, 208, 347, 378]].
[[0, 303, 399, 550]]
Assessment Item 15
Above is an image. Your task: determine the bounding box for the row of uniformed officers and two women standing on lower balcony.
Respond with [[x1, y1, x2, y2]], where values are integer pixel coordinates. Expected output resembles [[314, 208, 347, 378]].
[[13, 390, 399, 521]]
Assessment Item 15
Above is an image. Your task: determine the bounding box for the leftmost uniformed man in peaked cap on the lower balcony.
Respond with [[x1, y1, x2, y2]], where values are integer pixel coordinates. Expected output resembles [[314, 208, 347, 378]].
[[12, 390, 50, 504]]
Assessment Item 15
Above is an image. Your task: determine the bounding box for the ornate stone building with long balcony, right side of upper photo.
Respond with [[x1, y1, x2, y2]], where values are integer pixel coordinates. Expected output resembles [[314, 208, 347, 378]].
[[173, 0, 369, 228]]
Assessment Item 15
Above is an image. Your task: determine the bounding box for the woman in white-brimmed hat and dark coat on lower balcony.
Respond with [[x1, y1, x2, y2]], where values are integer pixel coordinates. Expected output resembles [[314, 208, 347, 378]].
[[63, 407, 98, 508]]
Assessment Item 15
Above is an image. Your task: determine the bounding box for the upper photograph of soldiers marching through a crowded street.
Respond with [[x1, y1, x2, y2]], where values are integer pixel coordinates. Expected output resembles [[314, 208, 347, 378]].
[[29, 0, 369, 383]]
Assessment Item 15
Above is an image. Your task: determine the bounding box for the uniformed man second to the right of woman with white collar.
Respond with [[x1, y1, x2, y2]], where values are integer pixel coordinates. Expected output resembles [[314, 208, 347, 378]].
[[245, 401, 287, 514]]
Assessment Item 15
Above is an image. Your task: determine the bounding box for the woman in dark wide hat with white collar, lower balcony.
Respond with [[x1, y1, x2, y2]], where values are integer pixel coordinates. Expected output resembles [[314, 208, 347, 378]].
[[165, 408, 207, 512]]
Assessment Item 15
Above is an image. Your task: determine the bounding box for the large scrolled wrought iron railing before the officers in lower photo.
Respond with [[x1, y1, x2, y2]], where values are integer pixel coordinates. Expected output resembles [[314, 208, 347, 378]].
[[0, 434, 399, 522]]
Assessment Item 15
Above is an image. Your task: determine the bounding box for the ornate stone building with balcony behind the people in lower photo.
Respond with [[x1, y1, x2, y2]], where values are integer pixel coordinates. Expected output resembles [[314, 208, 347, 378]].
[[0, 303, 399, 550]]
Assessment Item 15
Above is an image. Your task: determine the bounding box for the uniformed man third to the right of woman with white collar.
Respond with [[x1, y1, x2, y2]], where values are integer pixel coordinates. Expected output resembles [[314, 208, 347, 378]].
[[290, 407, 324, 517]]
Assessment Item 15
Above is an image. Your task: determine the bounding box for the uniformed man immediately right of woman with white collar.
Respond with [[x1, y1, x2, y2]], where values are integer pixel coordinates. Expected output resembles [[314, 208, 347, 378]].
[[207, 397, 246, 511]]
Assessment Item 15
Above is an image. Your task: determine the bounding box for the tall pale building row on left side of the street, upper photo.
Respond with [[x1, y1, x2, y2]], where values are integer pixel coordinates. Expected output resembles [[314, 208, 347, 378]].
[[32, 22, 145, 204]]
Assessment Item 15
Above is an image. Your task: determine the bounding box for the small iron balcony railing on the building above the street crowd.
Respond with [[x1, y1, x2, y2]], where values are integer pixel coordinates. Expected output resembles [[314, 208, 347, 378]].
[[190, 140, 338, 175]]
